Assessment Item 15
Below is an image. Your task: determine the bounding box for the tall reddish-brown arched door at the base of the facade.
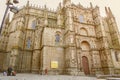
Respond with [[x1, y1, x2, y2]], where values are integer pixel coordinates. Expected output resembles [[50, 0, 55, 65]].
[[82, 56, 90, 75]]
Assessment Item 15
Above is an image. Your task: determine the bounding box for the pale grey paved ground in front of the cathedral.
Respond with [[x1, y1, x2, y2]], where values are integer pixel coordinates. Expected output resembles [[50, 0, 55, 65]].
[[0, 74, 97, 80]]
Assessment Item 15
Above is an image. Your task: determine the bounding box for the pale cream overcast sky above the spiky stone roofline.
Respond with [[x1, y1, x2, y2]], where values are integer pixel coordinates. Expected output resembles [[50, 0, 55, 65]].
[[0, 0, 120, 31]]
